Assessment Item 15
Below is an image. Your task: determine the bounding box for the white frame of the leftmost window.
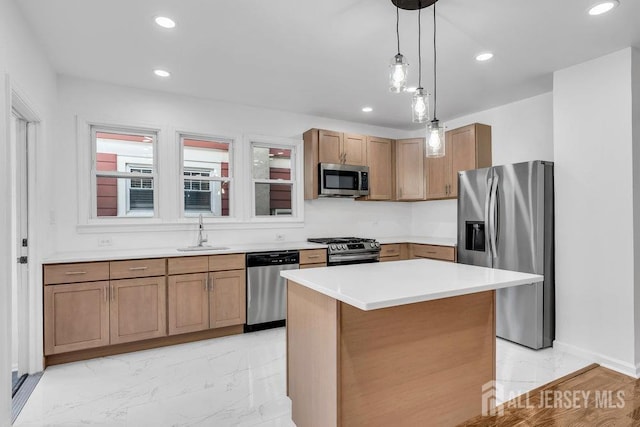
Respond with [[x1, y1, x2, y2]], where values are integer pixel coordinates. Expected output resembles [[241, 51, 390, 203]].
[[89, 123, 160, 223]]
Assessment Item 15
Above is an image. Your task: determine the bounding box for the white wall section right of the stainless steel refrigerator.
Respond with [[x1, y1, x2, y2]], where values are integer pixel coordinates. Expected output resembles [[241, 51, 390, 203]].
[[553, 48, 640, 375]]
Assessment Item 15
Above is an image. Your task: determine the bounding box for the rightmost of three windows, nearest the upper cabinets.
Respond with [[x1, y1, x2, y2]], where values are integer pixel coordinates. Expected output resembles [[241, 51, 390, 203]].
[[251, 142, 297, 217]]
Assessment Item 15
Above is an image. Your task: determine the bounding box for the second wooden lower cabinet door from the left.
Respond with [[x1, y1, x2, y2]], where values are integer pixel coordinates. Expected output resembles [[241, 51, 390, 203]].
[[109, 276, 167, 344]]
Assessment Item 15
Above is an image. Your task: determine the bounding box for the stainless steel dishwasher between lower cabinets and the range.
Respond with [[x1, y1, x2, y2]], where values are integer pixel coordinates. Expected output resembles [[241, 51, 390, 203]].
[[245, 251, 300, 332]]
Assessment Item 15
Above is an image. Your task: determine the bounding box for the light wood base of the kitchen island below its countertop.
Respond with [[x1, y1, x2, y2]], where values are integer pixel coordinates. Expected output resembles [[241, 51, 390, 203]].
[[287, 281, 495, 427]]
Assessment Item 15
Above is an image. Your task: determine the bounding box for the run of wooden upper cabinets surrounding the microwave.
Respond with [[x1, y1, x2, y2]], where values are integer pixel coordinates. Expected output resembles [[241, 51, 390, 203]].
[[304, 123, 491, 202]]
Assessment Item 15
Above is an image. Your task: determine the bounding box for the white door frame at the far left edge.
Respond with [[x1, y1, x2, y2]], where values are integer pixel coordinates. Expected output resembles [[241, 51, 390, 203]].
[[7, 76, 44, 374]]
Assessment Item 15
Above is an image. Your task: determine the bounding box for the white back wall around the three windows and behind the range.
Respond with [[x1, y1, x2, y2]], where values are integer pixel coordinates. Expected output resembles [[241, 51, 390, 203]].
[[48, 76, 411, 252]]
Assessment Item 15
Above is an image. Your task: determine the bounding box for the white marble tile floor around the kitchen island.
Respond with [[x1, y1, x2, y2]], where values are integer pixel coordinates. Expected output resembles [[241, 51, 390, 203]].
[[14, 328, 589, 427]]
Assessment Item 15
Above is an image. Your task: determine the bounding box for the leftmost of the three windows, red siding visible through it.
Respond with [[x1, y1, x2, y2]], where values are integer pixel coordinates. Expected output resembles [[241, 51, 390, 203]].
[[91, 126, 157, 218]]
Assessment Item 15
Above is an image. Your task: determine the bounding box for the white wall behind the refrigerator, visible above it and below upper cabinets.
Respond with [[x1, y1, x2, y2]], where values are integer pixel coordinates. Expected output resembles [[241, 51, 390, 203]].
[[411, 93, 553, 237]]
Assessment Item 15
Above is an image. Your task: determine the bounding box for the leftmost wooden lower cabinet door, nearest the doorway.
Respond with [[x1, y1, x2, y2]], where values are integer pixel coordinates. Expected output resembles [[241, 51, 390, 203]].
[[44, 281, 109, 355]]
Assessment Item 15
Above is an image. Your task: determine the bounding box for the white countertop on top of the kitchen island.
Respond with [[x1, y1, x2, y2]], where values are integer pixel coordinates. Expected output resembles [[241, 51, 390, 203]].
[[280, 259, 543, 310]]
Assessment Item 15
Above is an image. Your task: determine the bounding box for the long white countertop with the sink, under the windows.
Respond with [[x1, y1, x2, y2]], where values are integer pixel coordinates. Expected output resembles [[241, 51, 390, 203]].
[[43, 242, 327, 264]]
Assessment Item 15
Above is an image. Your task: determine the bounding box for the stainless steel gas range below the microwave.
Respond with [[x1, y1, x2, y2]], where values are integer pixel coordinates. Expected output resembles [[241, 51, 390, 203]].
[[307, 237, 380, 266]]
